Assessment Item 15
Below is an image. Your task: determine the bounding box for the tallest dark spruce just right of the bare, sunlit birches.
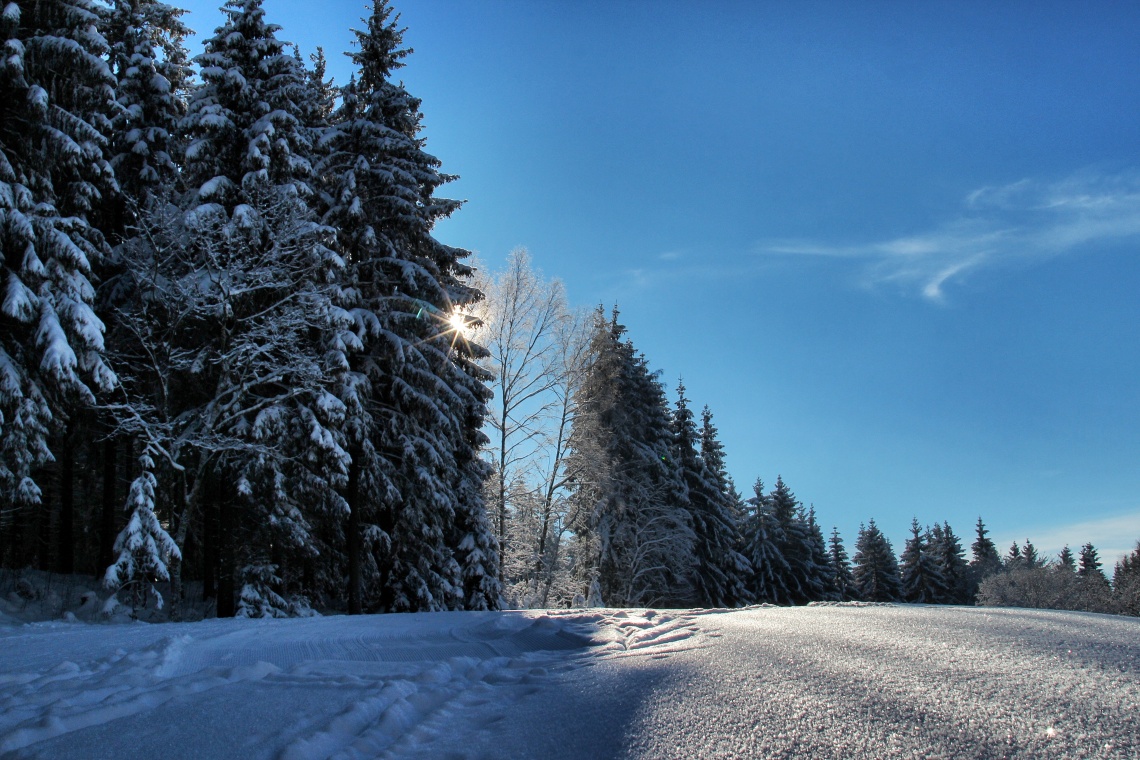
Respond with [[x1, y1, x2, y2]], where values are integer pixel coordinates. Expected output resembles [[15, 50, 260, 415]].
[[568, 308, 694, 606]]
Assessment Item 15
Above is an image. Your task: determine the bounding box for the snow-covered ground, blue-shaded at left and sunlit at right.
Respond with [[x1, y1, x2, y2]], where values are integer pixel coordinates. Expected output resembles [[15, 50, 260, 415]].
[[0, 605, 1140, 760]]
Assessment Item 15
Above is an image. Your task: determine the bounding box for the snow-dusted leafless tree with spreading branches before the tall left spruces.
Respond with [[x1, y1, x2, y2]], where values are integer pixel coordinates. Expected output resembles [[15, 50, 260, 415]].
[[111, 194, 347, 615]]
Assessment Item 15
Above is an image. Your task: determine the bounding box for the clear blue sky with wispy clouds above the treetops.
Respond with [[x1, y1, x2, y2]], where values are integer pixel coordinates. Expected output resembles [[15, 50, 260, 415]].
[[182, 0, 1140, 564]]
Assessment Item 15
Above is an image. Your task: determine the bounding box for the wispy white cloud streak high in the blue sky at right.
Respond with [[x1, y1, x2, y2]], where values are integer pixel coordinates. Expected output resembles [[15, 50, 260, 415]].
[[757, 171, 1140, 301]]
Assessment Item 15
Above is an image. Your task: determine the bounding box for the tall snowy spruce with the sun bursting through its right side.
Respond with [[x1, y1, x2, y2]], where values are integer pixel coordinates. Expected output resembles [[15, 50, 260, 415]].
[[319, 2, 499, 611]]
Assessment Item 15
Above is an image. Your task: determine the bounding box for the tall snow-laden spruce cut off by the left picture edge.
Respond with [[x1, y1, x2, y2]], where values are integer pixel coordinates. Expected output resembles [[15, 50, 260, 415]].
[[0, 0, 115, 546]]
